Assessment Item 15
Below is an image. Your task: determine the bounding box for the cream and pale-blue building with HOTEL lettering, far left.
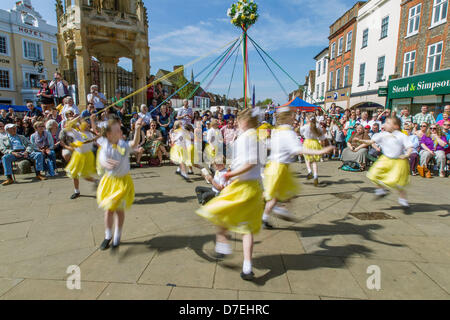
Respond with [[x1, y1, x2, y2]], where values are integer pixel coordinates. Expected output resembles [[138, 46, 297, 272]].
[[0, 0, 58, 105]]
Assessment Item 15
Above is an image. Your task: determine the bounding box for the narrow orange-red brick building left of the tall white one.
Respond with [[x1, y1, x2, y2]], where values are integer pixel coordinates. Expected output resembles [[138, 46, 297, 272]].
[[325, 1, 366, 109]]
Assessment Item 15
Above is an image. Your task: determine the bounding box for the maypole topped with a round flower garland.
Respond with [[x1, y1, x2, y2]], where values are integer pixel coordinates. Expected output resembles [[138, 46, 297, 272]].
[[227, 0, 259, 108]]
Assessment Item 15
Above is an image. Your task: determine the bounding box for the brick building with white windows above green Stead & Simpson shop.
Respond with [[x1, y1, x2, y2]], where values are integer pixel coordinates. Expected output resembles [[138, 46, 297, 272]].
[[388, 0, 450, 114]]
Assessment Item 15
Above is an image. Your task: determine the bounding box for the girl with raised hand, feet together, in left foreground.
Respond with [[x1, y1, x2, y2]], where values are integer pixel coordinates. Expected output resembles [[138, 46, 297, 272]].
[[97, 119, 143, 250]]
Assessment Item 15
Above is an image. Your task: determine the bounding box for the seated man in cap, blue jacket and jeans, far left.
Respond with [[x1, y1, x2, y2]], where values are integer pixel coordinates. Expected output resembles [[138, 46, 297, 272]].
[[0, 123, 47, 186]]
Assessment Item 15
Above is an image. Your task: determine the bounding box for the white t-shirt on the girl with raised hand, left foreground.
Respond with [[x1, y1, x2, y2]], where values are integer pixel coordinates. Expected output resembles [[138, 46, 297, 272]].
[[98, 139, 132, 177]]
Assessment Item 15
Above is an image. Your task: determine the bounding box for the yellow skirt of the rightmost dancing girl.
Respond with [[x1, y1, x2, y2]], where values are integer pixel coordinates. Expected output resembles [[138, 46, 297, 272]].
[[367, 155, 409, 189]]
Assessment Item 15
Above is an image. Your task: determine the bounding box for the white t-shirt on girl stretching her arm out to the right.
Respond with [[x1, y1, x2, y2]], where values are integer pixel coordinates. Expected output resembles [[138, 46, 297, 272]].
[[269, 125, 303, 163]]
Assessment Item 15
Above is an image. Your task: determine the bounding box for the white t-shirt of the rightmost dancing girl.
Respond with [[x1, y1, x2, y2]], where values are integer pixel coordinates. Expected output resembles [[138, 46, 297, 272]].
[[372, 130, 413, 159]]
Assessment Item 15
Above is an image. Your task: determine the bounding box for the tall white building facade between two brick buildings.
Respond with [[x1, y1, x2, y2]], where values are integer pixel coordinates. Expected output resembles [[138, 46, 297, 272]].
[[350, 0, 402, 108]]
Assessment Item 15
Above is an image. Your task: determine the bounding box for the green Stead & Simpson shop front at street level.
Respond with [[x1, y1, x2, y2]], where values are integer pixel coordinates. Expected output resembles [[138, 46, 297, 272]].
[[387, 69, 450, 115]]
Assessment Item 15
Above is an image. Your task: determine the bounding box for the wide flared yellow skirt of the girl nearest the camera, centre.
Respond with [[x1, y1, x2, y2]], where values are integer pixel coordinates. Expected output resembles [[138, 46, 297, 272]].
[[196, 180, 264, 234]]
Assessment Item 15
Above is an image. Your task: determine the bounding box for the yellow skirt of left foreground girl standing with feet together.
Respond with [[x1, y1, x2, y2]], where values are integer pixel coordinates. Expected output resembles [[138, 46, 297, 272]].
[[97, 174, 134, 211]]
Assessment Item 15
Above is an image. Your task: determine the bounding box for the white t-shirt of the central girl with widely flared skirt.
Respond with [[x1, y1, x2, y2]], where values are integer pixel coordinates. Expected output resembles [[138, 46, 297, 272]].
[[231, 129, 261, 181]]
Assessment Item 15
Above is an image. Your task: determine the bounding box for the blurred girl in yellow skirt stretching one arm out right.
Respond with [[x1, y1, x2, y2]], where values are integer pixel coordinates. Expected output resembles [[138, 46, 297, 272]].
[[263, 107, 334, 229]]
